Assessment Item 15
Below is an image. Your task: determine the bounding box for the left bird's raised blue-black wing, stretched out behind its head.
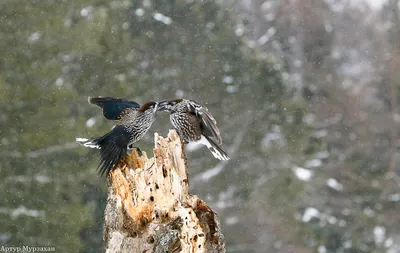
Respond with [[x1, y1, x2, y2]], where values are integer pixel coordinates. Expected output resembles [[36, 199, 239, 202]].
[[89, 97, 140, 120]]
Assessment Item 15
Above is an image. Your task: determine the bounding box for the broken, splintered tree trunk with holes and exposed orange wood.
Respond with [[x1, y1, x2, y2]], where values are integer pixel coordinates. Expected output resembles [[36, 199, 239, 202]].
[[104, 130, 225, 253]]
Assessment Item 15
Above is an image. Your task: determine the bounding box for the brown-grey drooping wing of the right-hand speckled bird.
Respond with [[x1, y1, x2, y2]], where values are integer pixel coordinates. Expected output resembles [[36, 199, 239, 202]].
[[189, 100, 222, 145]]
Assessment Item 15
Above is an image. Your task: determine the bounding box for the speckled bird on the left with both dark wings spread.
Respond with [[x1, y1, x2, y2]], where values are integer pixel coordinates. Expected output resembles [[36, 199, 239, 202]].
[[76, 97, 158, 175]]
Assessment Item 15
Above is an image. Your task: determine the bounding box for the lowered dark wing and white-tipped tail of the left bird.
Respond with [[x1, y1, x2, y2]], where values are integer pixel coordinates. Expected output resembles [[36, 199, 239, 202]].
[[76, 126, 129, 176]]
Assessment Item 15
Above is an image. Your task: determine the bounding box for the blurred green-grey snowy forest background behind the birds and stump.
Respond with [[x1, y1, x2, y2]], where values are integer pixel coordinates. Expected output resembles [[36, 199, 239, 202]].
[[0, 0, 400, 253]]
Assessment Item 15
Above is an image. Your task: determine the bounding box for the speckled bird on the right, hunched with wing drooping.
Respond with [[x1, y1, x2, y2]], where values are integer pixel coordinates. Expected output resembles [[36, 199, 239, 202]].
[[158, 99, 229, 160]]
